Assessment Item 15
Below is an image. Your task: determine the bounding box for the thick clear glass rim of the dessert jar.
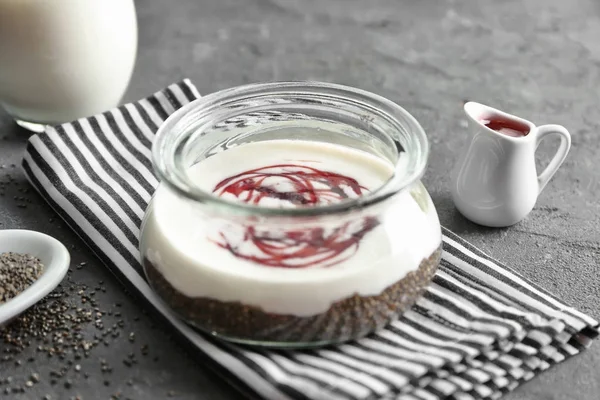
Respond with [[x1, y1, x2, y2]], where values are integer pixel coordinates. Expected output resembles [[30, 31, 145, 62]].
[[152, 81, 429, 217]]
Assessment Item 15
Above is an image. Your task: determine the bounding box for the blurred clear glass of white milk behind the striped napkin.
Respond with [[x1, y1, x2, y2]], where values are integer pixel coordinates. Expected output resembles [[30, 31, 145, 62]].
[[0, 0, 137, 130]]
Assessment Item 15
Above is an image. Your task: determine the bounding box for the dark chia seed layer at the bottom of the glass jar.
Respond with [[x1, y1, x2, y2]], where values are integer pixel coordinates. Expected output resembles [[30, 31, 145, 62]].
[[143, 247, 442, 346]]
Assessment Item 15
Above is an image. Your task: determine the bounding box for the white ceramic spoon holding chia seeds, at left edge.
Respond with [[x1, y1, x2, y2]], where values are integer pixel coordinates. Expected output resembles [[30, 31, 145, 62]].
[[0, 229, 71, 326]]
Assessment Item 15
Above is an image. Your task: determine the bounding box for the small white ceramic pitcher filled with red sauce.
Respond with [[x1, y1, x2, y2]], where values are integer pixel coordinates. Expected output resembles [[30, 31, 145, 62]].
[[451, 102, 571, 227]]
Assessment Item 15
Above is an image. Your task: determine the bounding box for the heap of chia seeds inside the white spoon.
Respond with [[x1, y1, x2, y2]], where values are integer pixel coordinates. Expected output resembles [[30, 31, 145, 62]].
[[0, 252, 44, 304]]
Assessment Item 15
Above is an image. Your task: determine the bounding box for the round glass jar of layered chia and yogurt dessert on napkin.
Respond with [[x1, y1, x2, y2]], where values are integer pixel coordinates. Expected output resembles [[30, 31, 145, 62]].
[[140, 82, 442, 347]]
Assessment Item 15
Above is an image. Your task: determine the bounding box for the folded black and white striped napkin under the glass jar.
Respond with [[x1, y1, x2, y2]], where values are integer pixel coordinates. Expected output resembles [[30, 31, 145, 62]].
[[23, 80, 598, 400]]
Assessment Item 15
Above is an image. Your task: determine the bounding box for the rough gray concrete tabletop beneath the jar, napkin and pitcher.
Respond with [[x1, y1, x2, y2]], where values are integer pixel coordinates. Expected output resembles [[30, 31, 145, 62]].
[[0, 0, 600, 400]]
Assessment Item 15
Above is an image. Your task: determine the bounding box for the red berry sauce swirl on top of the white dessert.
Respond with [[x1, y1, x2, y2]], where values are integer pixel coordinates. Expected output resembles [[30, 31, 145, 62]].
[[213, 164, 378, 268]]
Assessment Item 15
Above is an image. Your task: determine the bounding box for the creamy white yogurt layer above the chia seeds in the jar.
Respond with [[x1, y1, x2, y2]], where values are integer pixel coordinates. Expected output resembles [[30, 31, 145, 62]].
[[141, 140, 441, 316]]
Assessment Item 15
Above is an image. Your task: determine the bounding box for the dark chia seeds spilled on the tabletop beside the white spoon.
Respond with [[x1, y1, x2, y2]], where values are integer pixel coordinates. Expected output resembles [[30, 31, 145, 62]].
[[0, 274, 145, 398]]
